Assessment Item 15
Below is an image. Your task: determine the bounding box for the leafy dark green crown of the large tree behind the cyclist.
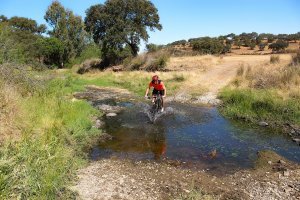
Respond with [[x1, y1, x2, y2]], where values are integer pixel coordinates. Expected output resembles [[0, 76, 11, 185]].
[[85, 0, 162, 64]]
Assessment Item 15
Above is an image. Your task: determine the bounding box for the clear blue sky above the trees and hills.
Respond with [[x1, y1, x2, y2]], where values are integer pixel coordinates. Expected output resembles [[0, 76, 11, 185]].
[[0, 0, 300, 48]]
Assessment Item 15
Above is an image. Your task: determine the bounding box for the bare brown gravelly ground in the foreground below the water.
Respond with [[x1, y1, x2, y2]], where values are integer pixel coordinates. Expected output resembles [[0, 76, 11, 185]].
[[72, 153, 300, 200]]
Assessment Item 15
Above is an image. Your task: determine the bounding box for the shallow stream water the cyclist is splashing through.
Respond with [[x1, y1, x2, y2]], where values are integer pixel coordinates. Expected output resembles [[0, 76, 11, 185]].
[[91, 102, 300, 171]]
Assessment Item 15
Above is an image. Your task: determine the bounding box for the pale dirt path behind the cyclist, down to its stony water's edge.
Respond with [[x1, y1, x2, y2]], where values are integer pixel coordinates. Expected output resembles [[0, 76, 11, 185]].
[[169, 54, 291, 105]]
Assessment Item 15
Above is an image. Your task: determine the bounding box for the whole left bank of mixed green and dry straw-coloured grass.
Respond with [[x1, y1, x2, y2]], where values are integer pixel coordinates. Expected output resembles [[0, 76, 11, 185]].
[[0, 71, 101, 199]]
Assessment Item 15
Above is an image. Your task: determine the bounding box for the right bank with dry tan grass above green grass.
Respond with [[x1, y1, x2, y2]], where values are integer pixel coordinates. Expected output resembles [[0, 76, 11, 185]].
[[219, 54, 300, 144]]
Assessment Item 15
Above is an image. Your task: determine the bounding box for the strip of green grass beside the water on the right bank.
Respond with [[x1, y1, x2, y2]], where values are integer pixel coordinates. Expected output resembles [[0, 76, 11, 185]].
[[220, 88, 300, 125]]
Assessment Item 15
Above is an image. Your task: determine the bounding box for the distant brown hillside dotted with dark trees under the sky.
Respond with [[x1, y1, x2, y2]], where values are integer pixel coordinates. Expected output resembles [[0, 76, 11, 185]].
[[148, 32, 300, 56]]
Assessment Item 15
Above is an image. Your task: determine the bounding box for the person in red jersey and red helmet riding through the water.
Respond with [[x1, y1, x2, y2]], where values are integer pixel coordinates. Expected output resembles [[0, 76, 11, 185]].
[[145, 75, 167, 112]]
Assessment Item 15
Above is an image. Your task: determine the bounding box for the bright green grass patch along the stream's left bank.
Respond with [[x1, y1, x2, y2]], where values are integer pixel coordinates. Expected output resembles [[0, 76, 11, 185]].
[[0, 77, 101, 199]]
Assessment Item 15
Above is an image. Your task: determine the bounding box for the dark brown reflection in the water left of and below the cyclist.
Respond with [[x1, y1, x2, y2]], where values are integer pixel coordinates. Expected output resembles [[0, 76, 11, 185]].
[[100, 109, 166, 159]]
